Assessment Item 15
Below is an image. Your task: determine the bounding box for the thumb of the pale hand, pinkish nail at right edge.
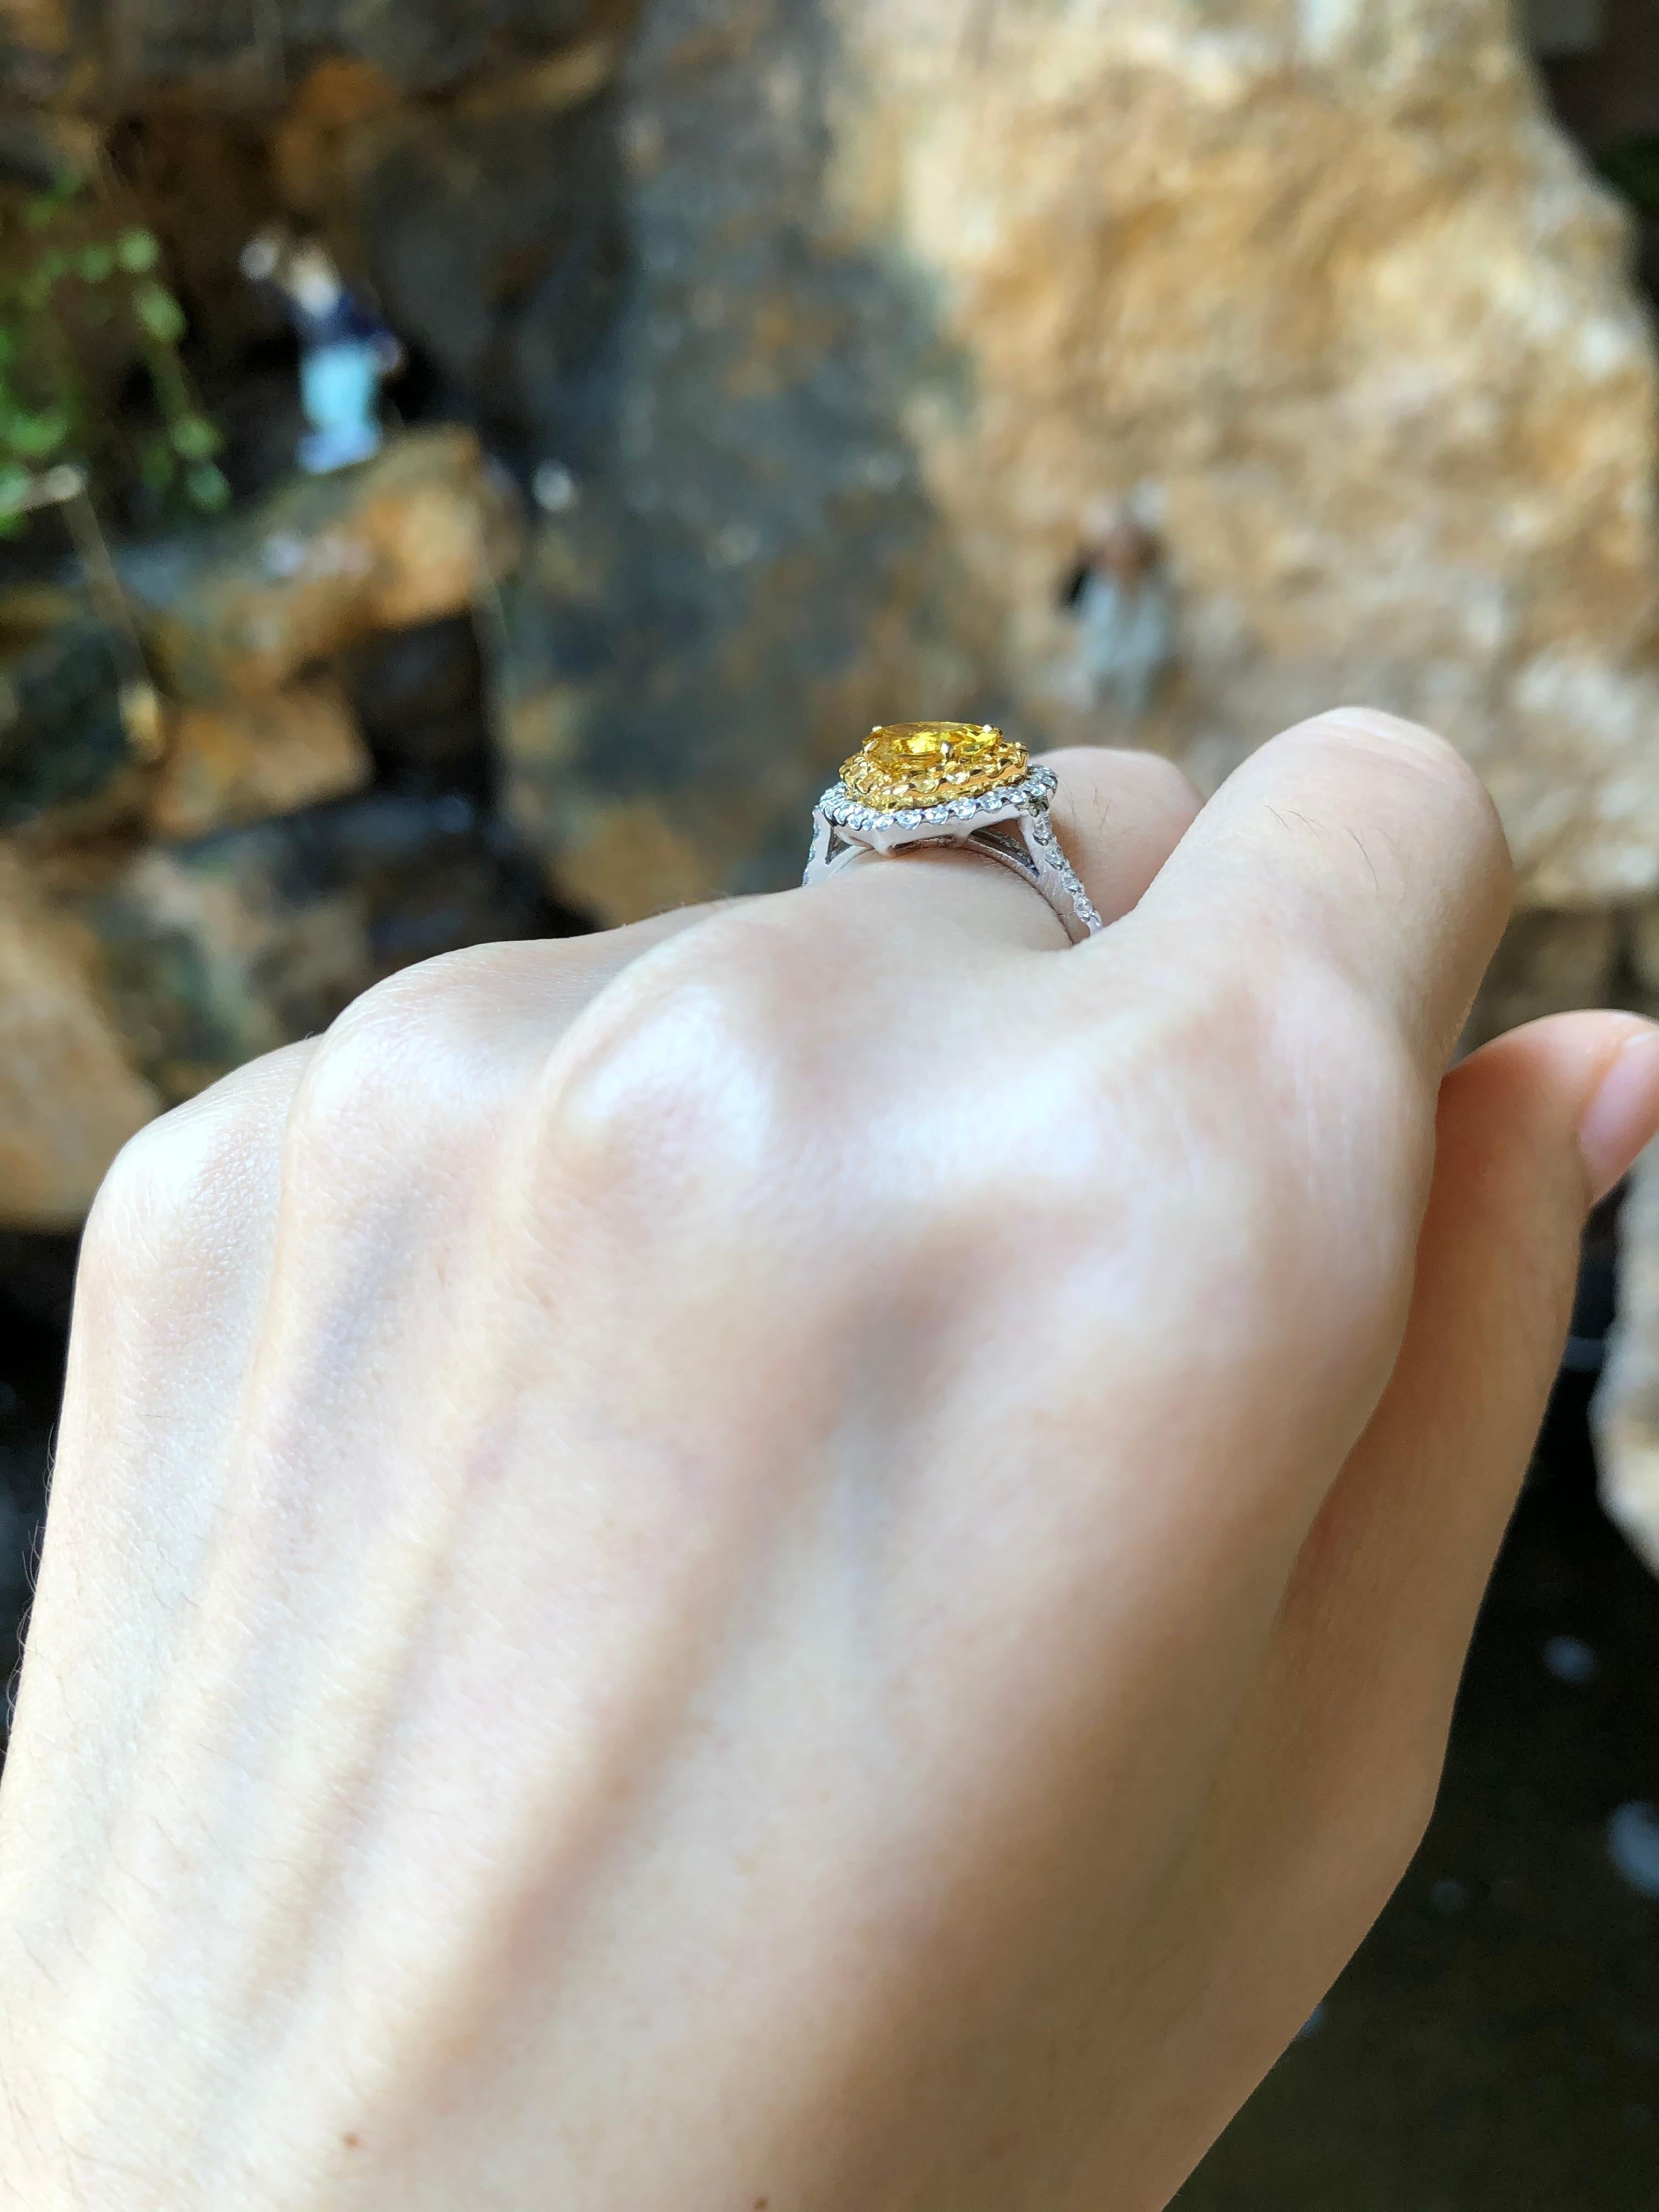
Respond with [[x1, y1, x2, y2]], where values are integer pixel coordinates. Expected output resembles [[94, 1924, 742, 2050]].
[[1283, 1013, 1659, 1728]]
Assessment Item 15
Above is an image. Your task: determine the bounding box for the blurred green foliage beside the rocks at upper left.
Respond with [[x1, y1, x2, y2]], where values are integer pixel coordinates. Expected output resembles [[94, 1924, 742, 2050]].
[[0, 179, 230, 535]]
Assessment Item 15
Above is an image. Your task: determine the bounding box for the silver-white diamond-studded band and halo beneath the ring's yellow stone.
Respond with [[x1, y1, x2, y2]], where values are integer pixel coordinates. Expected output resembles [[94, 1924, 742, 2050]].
[[808, 768, 1106, 945]]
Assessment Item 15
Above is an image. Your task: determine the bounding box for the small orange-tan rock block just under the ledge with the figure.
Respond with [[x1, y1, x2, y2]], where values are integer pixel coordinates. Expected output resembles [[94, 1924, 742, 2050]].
[[148, 681, 374, 838]]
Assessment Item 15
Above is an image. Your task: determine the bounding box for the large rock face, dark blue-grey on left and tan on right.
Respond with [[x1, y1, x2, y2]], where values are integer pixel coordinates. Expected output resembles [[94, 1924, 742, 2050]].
[[509, 0, 1659, 916]]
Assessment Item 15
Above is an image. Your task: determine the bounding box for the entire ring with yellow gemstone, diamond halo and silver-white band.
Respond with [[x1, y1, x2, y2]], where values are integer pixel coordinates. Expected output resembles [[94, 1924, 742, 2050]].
[[808, 721, 1106, 945]]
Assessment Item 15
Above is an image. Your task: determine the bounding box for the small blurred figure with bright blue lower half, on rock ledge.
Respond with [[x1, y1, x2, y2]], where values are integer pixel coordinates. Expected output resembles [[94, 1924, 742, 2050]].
[[241, 228, 405, 476]]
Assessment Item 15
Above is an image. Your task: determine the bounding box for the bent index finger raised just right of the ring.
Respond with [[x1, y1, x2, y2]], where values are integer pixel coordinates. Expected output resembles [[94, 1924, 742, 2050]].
[[1119, 708, 1513, 1080]]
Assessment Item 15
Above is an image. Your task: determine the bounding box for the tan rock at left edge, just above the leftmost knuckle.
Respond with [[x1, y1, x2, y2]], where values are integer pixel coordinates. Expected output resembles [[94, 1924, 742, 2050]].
[[0, 854, 161, 1230]]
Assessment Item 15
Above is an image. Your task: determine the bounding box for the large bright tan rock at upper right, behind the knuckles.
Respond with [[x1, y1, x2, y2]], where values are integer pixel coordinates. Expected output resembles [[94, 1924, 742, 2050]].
[[836, 0, 1659, 905]]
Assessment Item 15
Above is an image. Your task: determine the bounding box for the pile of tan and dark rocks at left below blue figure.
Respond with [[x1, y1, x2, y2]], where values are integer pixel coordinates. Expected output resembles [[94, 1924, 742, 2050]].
[[0, 429, 551, 1232]]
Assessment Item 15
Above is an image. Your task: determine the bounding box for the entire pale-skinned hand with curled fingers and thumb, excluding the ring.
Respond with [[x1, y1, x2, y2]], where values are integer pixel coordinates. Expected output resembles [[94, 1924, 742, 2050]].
[[0, 710, 1659, 2212]]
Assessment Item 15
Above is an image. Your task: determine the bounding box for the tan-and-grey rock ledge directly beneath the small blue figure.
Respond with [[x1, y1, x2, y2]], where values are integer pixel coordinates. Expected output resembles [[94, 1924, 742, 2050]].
[[128, 429, 517, 706]]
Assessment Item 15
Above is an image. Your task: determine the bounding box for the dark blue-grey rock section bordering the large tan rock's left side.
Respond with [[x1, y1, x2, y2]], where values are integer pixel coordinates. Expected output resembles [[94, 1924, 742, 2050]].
[[502, 0, 995, 920]]
